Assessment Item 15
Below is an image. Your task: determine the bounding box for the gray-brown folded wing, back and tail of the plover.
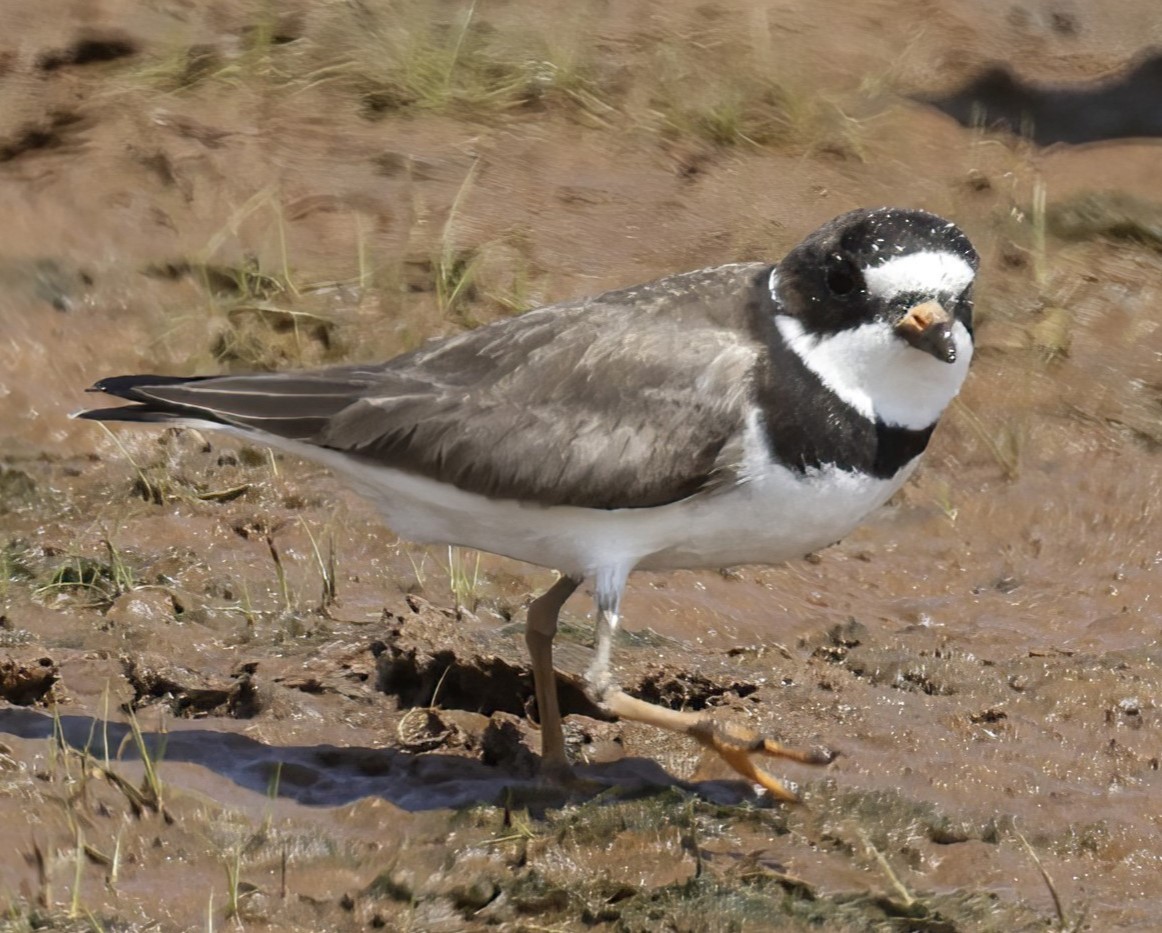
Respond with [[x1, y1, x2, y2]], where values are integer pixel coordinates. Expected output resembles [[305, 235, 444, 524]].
[[83, 263, 770, 509]]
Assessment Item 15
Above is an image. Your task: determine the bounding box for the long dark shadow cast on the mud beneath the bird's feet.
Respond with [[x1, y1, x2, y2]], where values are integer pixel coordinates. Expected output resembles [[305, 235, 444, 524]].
[[0, 706, 772, 816]]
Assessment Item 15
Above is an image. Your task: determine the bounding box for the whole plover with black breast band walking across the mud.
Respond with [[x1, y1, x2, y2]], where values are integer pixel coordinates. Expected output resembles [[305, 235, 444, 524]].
[[80, 208, 978, 799]]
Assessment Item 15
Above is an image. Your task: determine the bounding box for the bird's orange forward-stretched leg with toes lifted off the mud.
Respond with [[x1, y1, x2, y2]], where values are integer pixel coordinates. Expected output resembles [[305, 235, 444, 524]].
[[586, 589, 835, 802]]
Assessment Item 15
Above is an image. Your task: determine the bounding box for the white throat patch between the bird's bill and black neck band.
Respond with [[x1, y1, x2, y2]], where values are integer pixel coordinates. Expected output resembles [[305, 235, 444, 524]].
[[775, 314, 973, 430]]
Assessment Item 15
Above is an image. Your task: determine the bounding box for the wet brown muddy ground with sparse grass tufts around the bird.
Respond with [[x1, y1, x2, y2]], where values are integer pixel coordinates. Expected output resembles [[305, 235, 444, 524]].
[[0, 0, 1162, 931]]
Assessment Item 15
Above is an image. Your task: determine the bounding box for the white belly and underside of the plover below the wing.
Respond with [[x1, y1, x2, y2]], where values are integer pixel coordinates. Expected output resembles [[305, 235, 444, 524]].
[[131, 419, 918, 587]]
